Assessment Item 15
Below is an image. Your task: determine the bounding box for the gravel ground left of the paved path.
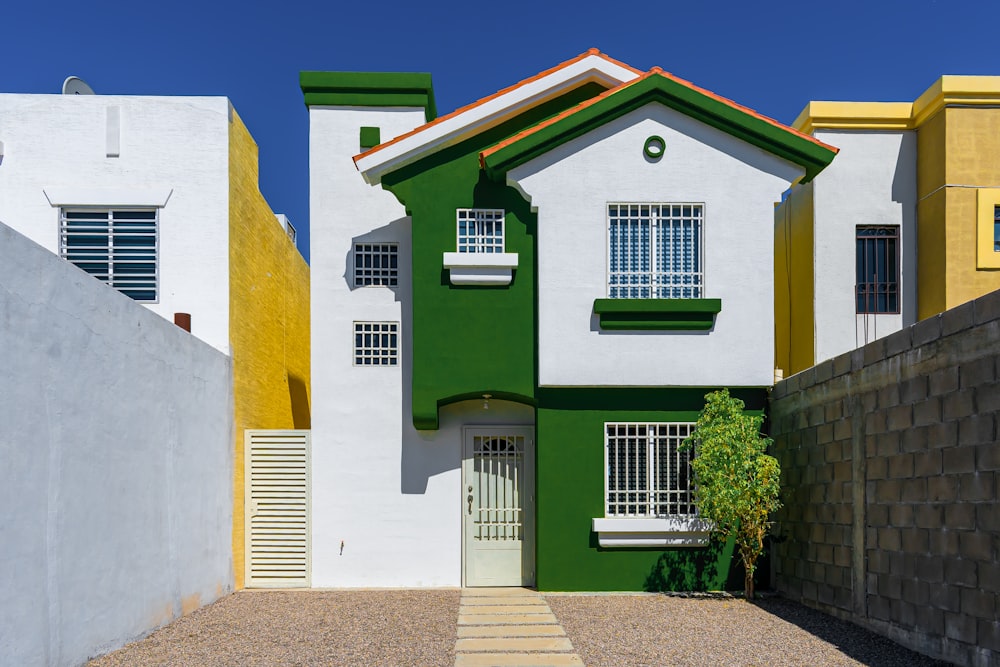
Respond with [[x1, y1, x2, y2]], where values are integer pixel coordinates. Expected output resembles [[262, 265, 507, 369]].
[[88, 590, 460, 667]]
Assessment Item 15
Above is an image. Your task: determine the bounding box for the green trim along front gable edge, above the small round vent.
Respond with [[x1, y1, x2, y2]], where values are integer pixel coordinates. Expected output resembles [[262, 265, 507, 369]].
[[485, 74, 837, 182]]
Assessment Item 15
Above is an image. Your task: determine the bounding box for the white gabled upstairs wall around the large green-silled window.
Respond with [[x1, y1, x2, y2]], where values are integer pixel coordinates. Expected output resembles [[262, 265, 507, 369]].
[[508, 104, 802, 386]]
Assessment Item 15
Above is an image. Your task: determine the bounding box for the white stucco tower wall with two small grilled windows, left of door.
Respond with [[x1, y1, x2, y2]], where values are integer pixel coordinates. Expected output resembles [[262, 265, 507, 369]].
[[309, 107, 482, 586]]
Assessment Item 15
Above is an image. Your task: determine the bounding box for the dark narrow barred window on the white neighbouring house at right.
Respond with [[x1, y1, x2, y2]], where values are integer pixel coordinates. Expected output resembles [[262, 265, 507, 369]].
[[855, 225, 899, 314]]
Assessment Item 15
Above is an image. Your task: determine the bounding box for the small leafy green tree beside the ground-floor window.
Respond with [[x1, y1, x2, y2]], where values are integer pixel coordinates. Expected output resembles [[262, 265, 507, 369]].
[[684, 389, 781, 600]]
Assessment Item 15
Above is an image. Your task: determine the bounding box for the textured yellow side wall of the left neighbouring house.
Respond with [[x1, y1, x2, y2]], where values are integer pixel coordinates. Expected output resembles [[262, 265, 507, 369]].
[[229, 111, 310, 589]]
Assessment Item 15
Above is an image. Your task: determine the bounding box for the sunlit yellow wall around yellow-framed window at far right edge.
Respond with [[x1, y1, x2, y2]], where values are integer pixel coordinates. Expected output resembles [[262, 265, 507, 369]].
[[944, 107, 1000, 308]]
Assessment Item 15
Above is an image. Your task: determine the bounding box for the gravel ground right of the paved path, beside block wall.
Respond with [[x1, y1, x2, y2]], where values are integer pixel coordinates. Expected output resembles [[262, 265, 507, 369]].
[[545, 595, 945, 667]]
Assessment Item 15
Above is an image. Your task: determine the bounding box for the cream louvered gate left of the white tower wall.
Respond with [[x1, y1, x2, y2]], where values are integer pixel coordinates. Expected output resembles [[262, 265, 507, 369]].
[[245, 431, 310, 588]]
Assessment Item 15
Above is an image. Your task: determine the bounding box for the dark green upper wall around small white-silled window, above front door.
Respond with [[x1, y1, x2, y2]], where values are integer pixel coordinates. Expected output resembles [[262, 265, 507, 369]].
[[382, 84, 604, 430]]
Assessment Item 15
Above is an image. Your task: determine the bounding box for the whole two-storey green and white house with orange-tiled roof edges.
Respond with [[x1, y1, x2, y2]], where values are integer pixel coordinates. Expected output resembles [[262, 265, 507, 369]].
[[301, 50, 836, 590]]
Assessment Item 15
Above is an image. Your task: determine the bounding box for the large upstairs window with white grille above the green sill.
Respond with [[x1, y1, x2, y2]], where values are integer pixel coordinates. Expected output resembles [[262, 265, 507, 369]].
[[608, 204, 705, 299]]
